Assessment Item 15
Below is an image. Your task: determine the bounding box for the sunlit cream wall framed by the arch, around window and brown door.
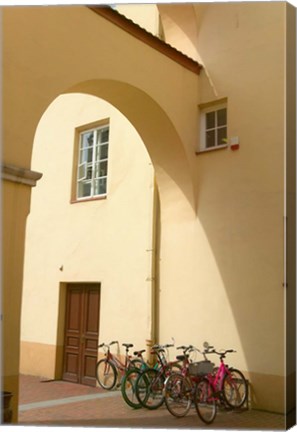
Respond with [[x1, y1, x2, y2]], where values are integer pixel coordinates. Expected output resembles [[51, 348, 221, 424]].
[[21, 94, 154, 374]]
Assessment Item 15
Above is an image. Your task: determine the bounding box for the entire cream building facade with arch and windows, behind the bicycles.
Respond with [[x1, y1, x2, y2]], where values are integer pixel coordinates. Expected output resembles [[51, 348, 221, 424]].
[[2, 2, 295, 420]]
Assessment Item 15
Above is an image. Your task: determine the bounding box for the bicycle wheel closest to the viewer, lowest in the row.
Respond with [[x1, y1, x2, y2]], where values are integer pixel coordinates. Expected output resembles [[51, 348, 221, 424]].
[[194, 378, 217, 424]]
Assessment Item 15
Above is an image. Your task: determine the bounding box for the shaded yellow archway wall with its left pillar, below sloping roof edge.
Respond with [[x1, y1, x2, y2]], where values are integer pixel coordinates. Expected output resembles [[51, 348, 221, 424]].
[[2, 6, 199, 420]]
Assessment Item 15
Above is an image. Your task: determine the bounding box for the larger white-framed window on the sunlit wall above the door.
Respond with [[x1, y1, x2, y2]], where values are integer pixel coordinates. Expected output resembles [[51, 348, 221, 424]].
[[76, 126, 109, 200]]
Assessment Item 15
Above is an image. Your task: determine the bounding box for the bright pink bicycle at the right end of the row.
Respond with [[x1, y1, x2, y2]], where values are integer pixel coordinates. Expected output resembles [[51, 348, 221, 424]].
[[204, 342, 248, 409]]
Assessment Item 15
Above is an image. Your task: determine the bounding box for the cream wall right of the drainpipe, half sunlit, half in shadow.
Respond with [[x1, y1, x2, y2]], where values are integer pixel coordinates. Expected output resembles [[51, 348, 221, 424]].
[[155, 3, 285, 411]]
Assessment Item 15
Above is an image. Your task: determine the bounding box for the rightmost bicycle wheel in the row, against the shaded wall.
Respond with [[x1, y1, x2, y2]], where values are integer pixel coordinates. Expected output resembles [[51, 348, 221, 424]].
[[222, 369, 248, 408]]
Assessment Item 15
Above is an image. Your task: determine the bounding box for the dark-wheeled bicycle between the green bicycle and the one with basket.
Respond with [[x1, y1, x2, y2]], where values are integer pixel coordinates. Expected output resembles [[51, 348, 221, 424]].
[[135, 344, 180, 410]]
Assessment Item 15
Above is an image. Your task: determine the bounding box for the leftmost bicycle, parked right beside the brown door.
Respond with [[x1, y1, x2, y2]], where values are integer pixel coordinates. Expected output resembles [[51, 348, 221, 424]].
[[96, 341, 145, 390]]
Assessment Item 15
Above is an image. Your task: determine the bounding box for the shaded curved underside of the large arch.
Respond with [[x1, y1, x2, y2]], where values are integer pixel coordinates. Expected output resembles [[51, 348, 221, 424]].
[[64, 79, 195, 211]]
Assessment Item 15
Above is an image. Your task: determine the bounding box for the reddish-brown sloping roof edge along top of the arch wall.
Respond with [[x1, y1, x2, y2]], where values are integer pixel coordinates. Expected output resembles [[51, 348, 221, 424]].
[[87, 6, 202, 75]]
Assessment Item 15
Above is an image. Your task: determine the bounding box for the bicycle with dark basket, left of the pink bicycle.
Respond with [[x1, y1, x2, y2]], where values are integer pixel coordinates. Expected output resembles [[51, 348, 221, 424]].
[[164, 345, 217, 424]]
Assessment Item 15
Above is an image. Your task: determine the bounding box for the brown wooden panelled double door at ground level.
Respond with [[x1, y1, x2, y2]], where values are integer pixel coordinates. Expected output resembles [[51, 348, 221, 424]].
[[63, 284, 100, 386]]
